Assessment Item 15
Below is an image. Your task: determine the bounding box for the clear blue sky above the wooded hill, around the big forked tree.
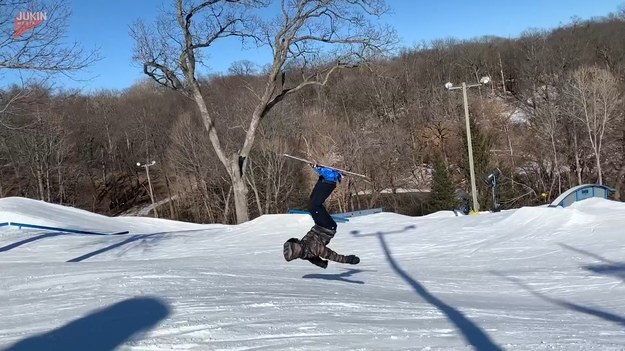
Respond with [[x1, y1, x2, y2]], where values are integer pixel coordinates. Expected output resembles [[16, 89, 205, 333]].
[[0, 0, 623, 91]]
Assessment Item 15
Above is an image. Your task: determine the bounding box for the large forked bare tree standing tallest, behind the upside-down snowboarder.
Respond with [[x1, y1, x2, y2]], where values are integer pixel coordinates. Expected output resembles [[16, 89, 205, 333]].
[[131, 0, 395, 223]]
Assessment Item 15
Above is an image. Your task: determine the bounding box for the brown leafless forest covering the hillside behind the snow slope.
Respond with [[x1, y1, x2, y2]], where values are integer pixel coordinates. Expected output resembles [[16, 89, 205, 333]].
[[0, 14, 625, 223]]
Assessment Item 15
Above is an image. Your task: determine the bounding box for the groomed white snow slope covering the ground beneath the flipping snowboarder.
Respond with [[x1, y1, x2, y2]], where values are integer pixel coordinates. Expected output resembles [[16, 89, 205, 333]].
[[0, 198, 625, 351]]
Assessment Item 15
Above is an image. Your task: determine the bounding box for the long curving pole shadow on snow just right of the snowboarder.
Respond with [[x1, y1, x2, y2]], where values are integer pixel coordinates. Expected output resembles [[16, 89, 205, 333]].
[[370, 229, 502, 351]]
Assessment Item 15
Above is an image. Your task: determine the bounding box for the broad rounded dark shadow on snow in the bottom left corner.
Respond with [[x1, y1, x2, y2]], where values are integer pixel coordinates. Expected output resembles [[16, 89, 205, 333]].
[[4, 297, 170, 351]]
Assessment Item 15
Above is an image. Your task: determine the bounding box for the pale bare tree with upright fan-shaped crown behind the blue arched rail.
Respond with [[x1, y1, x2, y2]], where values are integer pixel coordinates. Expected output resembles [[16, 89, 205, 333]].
[[569, 67, 621, 184]]
